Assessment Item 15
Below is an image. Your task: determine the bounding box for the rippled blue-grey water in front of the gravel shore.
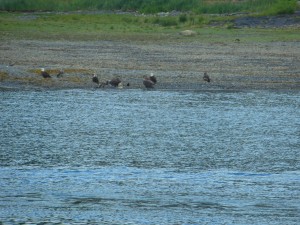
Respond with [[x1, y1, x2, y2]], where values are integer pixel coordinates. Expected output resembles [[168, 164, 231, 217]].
[[0, 89, 300, 224]]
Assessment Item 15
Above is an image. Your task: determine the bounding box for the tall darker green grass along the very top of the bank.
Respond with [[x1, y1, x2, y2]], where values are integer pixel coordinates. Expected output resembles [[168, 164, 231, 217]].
[[0, 0, 297, 14]]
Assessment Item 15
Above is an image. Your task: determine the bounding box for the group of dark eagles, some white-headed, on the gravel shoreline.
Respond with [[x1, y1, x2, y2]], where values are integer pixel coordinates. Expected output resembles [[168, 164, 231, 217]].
[[41, 68, 210, 88]]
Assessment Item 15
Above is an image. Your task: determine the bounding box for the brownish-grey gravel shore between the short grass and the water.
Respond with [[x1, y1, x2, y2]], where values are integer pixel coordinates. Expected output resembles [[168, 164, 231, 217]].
[[0, 40, 300, 90]]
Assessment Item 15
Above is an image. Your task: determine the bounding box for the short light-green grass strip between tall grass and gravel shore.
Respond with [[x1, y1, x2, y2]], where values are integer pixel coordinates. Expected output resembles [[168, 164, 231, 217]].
[[0, 12, 300, 43]]
